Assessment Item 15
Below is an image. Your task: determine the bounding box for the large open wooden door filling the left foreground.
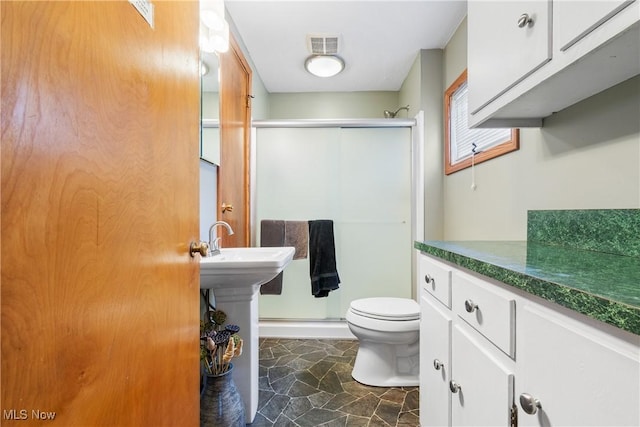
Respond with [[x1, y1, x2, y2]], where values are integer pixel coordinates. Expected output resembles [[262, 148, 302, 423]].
[[1, 1, 200, 426]]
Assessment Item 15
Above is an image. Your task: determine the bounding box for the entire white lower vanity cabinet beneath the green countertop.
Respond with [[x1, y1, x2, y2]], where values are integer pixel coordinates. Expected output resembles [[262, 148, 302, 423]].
[[418, 253, 640, 427]]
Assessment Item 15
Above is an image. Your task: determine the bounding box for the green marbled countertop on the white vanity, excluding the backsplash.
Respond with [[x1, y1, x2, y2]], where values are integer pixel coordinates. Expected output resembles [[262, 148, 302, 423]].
[[414, 241, 640, 335]]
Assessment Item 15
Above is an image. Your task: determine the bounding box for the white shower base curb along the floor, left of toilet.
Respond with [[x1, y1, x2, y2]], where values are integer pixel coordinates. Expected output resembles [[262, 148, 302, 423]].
[[258, 320, 356, 340]]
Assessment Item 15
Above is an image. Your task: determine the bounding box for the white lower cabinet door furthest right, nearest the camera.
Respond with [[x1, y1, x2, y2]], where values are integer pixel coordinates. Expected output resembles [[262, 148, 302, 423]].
[[516, 306, 640, 426]]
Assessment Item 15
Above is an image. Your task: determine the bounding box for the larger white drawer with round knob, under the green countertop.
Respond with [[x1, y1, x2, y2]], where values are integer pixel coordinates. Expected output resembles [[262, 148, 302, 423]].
[[453, 271, 516, 359]]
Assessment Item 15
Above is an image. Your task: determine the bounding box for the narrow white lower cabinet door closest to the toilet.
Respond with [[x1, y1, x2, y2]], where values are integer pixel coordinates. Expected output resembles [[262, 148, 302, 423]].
[[420, 290, 451, 427]]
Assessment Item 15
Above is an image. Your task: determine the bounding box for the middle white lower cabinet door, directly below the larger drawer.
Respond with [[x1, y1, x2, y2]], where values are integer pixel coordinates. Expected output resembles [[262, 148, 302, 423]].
[[451, 325, 513, 427]]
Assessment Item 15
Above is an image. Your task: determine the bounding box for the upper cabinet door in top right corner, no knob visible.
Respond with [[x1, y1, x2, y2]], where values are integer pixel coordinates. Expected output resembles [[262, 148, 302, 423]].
[[553, 0, 637, 51]]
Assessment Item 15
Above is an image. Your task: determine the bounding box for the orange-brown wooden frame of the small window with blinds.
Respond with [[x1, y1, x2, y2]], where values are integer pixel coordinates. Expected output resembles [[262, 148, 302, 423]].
[[444, 69, 520, 175]]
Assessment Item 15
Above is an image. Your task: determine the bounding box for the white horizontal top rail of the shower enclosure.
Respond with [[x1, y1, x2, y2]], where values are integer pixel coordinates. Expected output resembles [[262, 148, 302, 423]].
[[251, 119, 416, 128]]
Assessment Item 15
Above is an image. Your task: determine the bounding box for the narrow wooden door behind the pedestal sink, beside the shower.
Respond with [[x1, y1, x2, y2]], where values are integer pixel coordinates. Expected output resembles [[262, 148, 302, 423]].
[[218, 37, 251, 247]]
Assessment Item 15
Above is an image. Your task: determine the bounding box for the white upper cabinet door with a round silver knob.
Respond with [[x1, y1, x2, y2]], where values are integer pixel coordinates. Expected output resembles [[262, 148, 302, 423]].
[[467, 0, 551, 114]]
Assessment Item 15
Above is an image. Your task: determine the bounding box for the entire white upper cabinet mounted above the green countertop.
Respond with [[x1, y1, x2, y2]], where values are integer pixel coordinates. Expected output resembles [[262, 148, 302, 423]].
[[467, 0, 640, 127]]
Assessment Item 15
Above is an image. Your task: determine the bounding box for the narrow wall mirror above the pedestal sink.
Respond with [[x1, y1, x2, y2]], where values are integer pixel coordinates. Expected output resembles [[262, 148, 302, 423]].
[[200, 51, 220, 166]]
